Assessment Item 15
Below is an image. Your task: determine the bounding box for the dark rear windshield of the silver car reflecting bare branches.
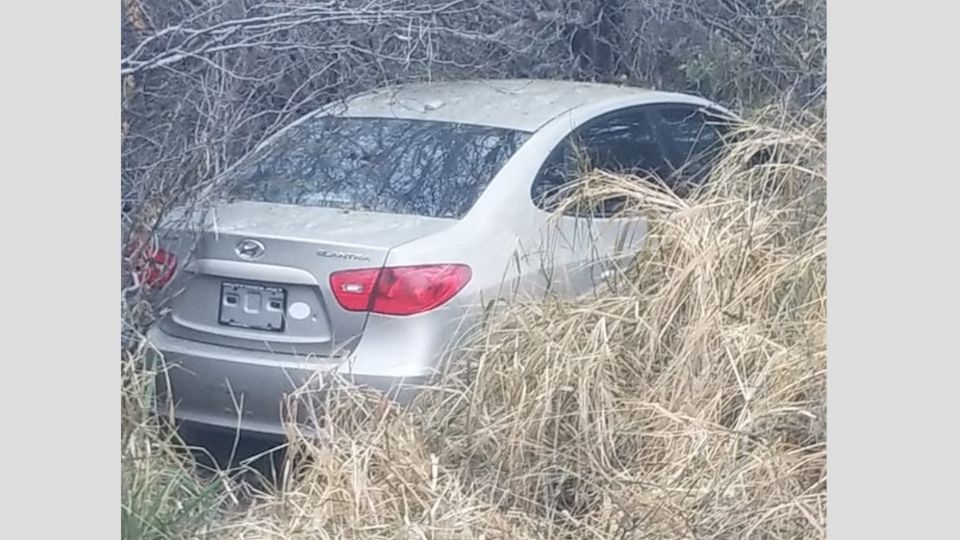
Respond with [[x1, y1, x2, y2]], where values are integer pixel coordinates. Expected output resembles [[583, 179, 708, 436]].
[[228, 116, 529, 218]]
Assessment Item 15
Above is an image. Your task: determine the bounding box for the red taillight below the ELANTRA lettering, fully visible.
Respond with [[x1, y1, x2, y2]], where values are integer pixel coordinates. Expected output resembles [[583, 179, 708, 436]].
[[330, 264, 472, 315]]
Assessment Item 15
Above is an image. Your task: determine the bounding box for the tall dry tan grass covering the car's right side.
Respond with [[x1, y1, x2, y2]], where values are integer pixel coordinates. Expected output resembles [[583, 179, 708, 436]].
[[120, 109, 826, 539]]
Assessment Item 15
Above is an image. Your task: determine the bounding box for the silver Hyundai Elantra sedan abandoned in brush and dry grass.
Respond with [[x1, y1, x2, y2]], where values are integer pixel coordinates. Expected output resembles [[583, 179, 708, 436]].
[[137, 80, 734, 435]]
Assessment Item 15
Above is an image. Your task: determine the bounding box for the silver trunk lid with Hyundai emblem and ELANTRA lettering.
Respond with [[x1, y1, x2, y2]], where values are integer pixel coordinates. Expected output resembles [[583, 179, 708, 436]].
[[161, 202, 456, 357]]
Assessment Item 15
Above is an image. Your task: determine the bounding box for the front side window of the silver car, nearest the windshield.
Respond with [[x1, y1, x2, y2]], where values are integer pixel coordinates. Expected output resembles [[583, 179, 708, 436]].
[[654, 105, 727, 188]]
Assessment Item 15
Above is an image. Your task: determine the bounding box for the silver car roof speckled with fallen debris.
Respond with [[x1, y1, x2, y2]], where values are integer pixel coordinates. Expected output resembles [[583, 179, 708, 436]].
[[333, 79, 706, 132]]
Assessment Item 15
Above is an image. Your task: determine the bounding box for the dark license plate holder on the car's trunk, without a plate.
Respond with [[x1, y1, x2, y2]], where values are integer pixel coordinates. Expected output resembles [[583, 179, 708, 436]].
[[219, 281, 287, 332]]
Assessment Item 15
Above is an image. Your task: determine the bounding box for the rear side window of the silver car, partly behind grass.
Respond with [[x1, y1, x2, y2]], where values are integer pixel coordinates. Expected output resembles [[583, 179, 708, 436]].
[[531, 109, 673, 216]]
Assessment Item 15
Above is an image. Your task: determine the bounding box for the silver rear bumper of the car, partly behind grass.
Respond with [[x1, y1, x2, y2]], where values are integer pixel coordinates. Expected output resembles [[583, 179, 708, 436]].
[[147, 328, 429, 435]]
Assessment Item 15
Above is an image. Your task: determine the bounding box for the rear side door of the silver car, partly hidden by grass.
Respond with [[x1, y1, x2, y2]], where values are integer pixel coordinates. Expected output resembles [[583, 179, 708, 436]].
[[531, 106, 672, 295]]
